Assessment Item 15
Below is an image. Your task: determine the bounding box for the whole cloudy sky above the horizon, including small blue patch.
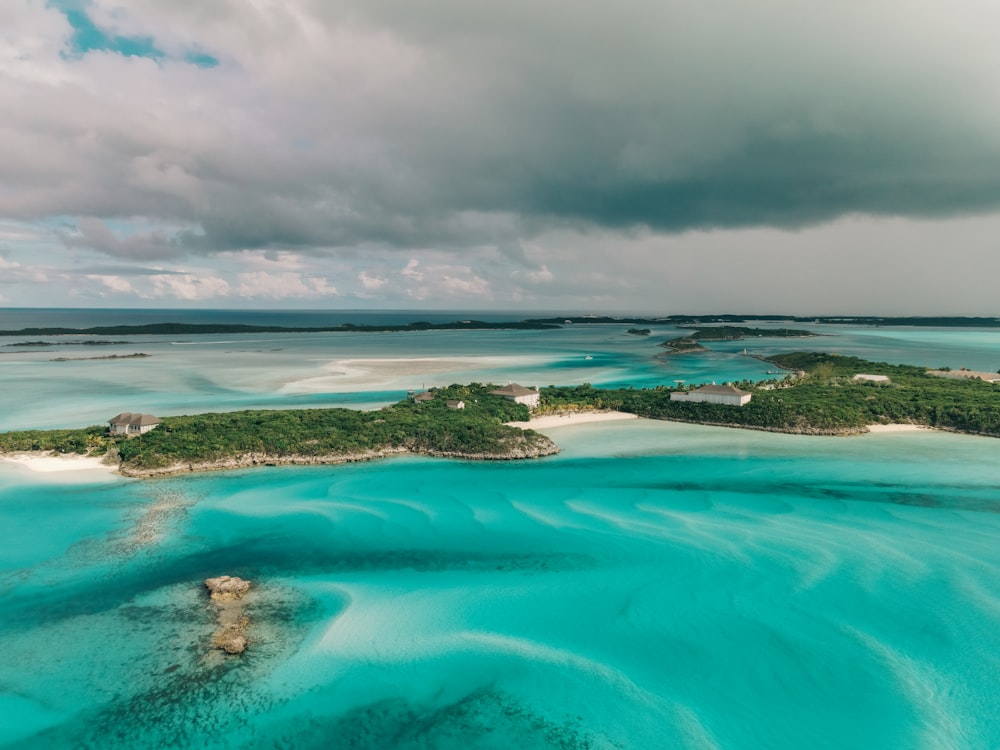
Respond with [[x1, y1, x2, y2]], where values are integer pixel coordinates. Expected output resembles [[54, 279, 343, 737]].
[[0, 0, 1000, 315]]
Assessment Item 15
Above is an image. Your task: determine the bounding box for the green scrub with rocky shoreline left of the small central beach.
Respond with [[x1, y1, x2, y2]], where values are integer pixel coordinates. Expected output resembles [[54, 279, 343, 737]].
[[0, 383, 555, 473]]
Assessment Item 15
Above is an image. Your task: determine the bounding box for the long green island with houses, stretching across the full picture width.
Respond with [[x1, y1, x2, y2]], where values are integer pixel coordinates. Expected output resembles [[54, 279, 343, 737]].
[[0, 352, 1000, 477]]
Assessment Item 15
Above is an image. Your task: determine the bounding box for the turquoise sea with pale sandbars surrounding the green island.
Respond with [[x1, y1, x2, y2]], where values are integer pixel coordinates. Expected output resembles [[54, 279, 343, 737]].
[[0, 310, 1000, 750]]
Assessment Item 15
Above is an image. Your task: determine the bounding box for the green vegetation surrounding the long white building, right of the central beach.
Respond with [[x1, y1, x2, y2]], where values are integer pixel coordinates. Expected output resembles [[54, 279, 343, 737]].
[[542, 352, 1000, 437]]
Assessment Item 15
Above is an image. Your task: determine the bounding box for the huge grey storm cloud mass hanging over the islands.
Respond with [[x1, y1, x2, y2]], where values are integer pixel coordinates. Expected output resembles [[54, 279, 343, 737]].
[[0, 0, 1000, 260]]
